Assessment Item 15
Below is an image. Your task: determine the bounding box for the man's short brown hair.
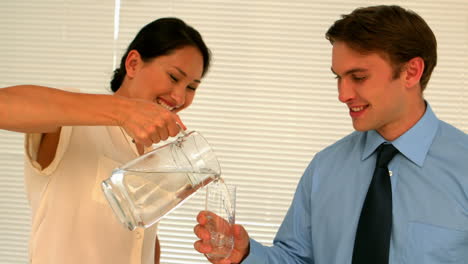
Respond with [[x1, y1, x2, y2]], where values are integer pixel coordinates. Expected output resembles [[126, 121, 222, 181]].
[[326, 5, 437, 90]]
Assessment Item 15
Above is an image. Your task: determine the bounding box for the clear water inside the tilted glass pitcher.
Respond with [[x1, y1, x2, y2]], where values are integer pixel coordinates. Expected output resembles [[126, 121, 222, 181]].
[[110, 169, 219, 227]]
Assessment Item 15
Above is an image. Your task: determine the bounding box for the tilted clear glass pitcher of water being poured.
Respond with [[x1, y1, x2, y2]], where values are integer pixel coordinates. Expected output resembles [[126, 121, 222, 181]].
[[101, 131, 221, 230]]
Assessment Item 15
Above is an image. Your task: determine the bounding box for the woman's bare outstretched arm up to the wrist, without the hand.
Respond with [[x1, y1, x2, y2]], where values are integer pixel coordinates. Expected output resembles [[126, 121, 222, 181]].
[[0, 85, 128, 133]]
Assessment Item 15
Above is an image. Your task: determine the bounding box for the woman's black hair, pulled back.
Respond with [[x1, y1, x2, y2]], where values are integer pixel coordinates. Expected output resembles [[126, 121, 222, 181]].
[[111, 17, 211, 92]]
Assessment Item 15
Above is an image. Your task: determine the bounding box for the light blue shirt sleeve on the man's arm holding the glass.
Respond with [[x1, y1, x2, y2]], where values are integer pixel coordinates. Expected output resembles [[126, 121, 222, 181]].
[[242, 162, 314, 264]]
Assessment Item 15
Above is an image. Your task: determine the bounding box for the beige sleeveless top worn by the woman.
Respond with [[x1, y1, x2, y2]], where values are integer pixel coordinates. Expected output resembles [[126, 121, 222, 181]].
[[25, 126, 156, 264]]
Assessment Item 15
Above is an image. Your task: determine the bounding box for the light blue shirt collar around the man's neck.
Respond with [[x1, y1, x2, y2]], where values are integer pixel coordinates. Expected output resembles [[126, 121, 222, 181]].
[[362, 102, 439, 167]]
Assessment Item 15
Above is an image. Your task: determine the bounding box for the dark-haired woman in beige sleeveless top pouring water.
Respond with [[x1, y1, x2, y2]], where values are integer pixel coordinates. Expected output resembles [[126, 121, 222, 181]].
[[0, 18, 210, 264]]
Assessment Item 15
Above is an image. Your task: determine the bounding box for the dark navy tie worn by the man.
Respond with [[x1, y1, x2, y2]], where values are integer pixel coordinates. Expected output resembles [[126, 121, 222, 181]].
[[353, 144, 398, 264]]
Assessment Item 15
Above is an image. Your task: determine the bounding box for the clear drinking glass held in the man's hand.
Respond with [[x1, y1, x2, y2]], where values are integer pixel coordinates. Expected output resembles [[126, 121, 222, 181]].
[[205, 180, 236, 260]]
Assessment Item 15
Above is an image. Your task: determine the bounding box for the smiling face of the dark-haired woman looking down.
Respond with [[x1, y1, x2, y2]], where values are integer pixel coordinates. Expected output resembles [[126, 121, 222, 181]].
[[116, 46, 203, 113]]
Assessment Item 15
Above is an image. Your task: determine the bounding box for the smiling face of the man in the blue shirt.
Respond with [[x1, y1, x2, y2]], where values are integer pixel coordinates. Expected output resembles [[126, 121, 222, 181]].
[[332, 42, 411, 140]]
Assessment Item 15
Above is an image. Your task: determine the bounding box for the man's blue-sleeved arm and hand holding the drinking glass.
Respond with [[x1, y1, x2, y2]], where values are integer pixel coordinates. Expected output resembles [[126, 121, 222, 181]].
[[194, 163, 314, 264]]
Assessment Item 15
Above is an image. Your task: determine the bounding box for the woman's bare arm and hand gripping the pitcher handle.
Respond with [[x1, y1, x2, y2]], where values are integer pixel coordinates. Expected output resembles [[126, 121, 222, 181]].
[[0, 85, 184, 146]]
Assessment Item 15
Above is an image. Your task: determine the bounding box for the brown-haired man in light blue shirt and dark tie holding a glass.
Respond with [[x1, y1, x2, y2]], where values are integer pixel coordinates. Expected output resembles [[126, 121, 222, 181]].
[[194, 6, 468, 264]]
